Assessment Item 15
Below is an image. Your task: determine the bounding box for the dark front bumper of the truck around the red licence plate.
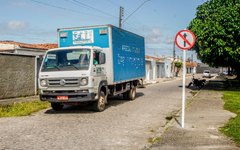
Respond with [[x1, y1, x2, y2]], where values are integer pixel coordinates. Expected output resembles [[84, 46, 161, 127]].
[[40, 92, 96, 103]]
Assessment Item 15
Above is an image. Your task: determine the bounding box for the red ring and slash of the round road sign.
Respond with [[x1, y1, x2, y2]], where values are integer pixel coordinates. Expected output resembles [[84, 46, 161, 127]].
[[175, 30, 196, 50]]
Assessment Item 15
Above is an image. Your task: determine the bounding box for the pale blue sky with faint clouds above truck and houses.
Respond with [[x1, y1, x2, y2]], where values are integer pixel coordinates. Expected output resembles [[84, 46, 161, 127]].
[[0, 0, 206, 58]]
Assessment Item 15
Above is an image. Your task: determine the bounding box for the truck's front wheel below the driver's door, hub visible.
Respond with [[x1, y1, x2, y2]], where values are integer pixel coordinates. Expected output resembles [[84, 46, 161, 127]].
[[93, 91, 106, 112]]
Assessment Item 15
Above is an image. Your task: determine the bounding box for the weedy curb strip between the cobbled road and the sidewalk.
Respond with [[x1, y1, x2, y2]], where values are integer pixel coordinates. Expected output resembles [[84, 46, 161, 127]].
[[145, 90, 201, 149]]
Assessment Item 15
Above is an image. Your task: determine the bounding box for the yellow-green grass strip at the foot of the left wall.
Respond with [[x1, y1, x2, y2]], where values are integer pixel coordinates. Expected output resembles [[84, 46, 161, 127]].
[[0, 100, 50, 117]]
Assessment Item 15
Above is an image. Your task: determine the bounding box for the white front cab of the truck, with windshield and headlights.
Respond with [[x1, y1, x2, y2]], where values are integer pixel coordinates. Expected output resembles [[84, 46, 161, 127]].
[[39, 46, 107, 110]]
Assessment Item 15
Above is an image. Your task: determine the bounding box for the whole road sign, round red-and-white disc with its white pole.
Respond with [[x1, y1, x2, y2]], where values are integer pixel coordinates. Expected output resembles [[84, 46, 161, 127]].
[[175, 30, 196, 128]]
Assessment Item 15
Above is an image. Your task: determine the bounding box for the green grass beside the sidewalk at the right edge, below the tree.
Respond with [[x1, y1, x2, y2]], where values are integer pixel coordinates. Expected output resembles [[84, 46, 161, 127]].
[[220, 91, 240, 144]]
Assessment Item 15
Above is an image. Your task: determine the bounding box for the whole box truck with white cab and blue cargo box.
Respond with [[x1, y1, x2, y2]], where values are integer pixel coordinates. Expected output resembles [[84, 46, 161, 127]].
[[39, 25, 145, 111]]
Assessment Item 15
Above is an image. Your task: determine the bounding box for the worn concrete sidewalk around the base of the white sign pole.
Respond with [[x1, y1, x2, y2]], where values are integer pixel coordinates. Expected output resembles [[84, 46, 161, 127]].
[[150, 78, 240, 150]]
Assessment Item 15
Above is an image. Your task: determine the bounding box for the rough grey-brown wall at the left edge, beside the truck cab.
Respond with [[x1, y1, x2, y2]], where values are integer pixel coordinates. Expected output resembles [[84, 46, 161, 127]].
[[0, 53, 39, 99]]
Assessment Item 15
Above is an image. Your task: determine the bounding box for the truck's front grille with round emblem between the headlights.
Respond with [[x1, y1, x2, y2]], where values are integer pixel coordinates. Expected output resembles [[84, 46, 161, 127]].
[[48, 79, 79, 87]]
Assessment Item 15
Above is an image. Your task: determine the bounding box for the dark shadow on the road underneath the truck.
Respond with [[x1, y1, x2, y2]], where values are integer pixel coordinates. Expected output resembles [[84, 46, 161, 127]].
[[45, 92, 144, 114]]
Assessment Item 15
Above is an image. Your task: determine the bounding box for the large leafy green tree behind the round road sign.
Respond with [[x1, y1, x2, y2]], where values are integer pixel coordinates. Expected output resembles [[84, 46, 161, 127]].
[[188, 0, 240, 77]]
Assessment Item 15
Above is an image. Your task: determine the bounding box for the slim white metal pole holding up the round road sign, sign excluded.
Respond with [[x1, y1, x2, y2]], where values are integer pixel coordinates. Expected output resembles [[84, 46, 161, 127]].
[[182, 50, 186, 128]]
